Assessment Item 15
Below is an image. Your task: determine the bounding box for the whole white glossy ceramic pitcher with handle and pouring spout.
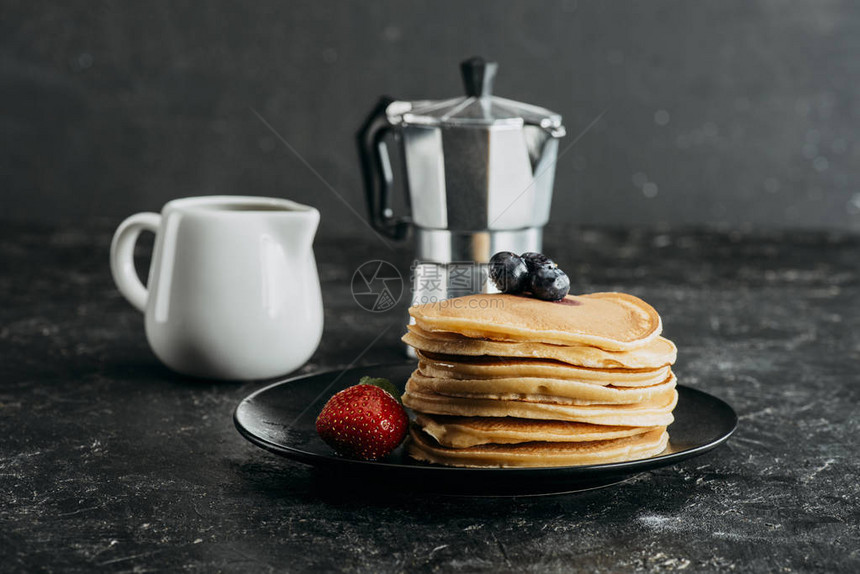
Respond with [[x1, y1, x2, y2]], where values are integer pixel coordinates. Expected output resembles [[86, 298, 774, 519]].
[[111, 196, 323, 380]]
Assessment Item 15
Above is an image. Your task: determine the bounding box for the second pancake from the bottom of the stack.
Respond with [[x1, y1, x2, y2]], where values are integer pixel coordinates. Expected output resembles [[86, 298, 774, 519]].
[[415, 413, 662, 448]]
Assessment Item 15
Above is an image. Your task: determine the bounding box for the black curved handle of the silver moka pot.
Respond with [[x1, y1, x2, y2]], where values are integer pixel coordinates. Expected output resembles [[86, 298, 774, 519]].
[[356, 96, 409, 240]]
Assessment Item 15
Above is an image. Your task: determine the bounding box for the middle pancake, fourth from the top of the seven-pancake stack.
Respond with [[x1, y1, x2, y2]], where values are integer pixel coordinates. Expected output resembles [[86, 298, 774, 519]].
[[407, 363, 675, 405]]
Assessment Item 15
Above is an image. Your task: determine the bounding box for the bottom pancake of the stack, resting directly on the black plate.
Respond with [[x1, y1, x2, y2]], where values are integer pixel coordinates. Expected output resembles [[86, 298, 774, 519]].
[[407, 426, 669, 467]]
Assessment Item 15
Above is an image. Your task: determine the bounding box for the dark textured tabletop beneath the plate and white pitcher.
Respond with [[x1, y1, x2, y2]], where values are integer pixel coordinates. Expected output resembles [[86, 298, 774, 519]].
[[0, 221, 860, 572]]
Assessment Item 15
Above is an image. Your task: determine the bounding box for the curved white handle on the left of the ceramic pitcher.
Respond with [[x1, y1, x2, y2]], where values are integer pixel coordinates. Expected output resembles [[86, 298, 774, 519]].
[[110, 212, 161, 313]]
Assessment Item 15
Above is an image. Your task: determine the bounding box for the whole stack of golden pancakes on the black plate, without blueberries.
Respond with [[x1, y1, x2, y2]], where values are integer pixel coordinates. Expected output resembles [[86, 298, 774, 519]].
[[403, 293, 678, 467]]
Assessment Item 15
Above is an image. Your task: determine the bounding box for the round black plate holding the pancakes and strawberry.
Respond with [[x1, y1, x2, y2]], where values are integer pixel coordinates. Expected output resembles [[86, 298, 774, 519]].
[[233, 363, 738, 496]]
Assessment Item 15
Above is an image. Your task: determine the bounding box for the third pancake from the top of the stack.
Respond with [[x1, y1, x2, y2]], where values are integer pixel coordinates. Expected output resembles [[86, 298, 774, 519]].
[[416, 351, 670, 387]]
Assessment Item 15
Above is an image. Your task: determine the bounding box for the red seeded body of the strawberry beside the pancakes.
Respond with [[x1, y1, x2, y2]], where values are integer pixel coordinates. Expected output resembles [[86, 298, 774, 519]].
[[316, 384, 409, 460]]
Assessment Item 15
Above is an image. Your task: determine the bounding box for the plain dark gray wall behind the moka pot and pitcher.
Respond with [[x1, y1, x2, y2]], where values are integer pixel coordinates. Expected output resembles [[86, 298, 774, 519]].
[[0, 0, 860, 235]]
